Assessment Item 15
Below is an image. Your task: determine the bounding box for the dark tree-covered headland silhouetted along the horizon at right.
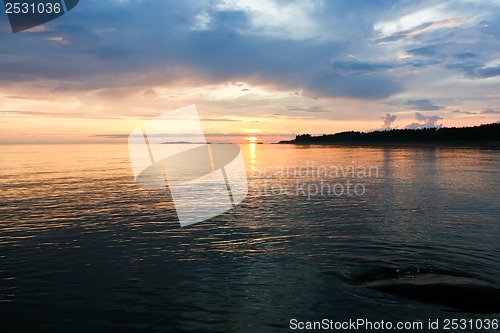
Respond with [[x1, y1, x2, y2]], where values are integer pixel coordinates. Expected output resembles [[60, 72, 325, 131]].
[[279, 122, 500, 147]]
